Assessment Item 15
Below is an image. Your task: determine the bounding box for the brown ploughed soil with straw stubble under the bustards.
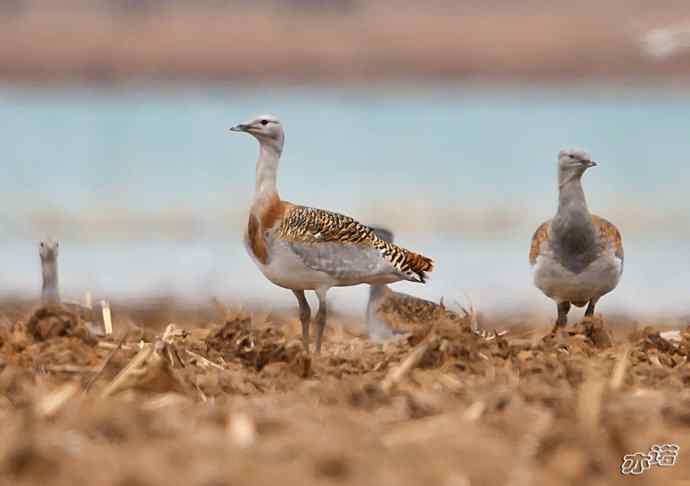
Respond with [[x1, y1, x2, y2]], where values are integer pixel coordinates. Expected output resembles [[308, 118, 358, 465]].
[[0, 302, 690, 486]]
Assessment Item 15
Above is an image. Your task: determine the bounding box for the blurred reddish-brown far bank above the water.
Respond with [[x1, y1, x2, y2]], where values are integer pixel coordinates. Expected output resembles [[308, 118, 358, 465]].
[[0, 0, 690, 84]]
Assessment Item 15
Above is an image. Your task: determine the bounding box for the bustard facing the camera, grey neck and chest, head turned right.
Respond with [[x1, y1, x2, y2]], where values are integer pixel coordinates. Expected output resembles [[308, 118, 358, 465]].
[[529, 149, 624, 332]]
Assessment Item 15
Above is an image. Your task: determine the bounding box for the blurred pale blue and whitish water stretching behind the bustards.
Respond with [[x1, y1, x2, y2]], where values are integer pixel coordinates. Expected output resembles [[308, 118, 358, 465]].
[[0, 86, 690, 314]]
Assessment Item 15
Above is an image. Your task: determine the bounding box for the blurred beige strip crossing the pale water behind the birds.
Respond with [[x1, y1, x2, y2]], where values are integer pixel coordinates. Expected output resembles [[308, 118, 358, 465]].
[[0, 195, 690, 243]]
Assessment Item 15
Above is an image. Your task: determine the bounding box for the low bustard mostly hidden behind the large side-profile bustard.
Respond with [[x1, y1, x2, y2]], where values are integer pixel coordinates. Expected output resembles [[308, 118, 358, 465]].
[[366, 226, 506, 342]]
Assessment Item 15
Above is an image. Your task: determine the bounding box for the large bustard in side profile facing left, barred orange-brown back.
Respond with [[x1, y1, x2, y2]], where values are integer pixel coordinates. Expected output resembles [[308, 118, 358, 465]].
[[230, 115, 433, 352]]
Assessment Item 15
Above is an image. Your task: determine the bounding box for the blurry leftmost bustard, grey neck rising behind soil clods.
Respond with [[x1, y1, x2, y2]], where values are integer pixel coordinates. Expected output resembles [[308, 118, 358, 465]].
[[38, 238, 111, 336]]
